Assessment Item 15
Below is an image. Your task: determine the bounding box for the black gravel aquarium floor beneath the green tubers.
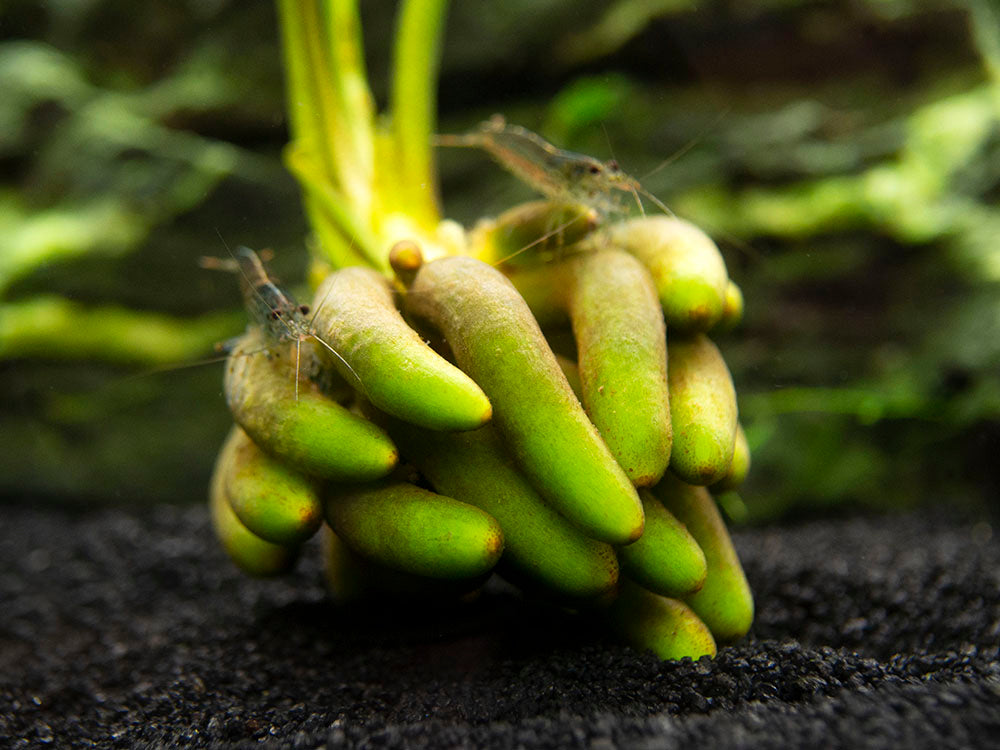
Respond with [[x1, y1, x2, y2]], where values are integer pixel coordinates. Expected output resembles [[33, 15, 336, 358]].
[[0, 505, 1000, 750]]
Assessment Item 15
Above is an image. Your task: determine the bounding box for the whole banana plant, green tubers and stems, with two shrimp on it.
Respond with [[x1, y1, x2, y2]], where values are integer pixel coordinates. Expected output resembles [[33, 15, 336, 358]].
[[210, 0, 753, 658]]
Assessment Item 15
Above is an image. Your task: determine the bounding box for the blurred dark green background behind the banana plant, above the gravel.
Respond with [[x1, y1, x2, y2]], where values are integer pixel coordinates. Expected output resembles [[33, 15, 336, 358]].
[[0, 0, 1000, 520]]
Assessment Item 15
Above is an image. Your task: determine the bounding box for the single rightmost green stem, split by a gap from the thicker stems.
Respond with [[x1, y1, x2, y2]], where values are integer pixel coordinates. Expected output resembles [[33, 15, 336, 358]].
[[391, 0, 448, 230]]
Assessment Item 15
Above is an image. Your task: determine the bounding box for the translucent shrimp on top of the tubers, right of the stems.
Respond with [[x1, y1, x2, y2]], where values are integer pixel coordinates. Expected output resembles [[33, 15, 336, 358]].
[[435, 115, 672, 216]]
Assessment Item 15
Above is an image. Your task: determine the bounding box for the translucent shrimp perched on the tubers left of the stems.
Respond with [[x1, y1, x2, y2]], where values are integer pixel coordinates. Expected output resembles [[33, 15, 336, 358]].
[[201, 246, 360, 401]]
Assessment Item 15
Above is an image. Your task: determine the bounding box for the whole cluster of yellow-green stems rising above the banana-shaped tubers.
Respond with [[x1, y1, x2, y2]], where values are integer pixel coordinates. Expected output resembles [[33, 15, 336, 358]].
[[278, 0, 447, 271]]
